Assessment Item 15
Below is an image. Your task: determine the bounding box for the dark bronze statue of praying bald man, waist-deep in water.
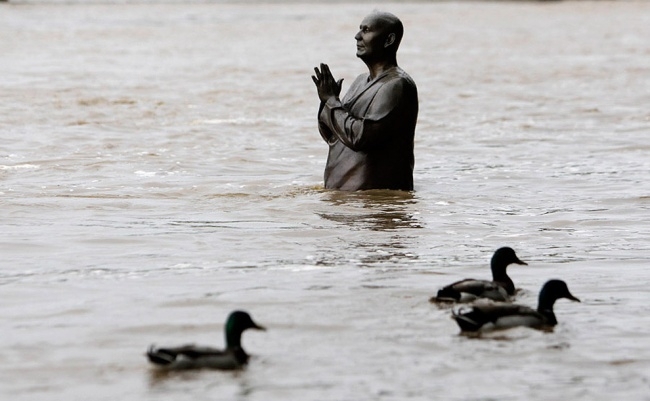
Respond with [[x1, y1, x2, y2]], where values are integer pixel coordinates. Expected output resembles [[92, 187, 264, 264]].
[[312, 11, 418, 191]]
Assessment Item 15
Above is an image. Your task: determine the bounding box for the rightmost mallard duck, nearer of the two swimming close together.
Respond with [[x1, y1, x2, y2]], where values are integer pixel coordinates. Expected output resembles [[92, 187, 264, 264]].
[[452, 280, 580, 332]]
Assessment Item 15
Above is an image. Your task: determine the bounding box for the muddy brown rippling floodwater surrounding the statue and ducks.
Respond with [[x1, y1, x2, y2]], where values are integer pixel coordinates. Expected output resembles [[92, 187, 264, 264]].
[[0, 1, 650, 400]]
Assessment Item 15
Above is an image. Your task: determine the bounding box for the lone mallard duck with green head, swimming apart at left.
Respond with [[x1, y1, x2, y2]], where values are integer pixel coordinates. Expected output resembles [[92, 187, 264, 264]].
[[147, 311, 266, 370]]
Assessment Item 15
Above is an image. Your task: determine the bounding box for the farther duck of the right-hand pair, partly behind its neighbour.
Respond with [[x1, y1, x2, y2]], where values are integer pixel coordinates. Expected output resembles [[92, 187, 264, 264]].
[[429, 247, 528, 302]]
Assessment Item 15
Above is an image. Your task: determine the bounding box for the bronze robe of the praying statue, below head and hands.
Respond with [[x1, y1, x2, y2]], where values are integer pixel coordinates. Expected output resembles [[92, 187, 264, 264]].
[[318, 67, 418, 191]]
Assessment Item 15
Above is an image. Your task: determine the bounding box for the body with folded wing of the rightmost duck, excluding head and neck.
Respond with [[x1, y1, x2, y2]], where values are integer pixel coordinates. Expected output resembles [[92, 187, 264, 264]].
[[452, 303, 544, 331]]
